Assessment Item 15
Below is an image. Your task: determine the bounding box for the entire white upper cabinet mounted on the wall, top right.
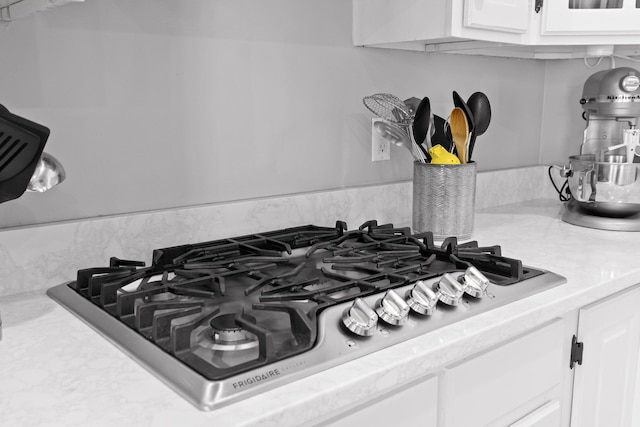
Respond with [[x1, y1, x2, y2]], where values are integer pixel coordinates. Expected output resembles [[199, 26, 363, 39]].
[[353, 0, 640, 59]]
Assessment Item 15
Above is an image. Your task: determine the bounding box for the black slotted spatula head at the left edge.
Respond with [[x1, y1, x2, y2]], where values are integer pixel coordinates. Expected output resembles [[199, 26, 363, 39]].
[[0, 107, 49, 203]]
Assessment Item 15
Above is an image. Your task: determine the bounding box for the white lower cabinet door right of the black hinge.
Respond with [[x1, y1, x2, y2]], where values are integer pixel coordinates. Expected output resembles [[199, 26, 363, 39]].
[[571, 288, 640, 427]]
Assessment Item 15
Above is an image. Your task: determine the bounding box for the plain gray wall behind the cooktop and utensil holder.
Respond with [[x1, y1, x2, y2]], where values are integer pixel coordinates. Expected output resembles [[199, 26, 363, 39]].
[[0, 0, 592, 228]]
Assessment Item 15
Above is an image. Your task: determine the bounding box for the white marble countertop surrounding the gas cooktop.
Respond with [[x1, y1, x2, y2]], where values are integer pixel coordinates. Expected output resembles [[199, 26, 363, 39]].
[[0, 199, 640, 427]]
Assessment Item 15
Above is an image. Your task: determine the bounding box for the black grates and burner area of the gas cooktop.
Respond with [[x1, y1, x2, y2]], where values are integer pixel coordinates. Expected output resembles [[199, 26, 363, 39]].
[[70, 221, 542, 380]]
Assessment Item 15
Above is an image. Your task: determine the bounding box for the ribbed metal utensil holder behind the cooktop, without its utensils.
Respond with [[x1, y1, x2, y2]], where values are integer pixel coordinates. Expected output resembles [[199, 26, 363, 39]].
[[413, 162, 477, 240]]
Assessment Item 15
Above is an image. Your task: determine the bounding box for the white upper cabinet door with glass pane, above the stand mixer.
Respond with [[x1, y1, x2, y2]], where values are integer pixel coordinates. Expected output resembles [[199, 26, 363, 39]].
[[542, 0, 640, 35]]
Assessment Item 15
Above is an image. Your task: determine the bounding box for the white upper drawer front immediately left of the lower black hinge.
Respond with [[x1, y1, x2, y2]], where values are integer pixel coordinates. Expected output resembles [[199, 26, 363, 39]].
[[441, 321, 568, 427]]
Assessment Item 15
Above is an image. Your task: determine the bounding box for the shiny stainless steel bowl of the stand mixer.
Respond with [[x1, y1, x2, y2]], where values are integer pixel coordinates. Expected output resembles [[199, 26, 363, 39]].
[[569, 154, 640, 217]]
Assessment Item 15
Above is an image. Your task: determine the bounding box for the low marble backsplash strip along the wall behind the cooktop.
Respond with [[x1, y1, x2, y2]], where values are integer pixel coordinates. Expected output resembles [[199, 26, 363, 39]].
[[0, 166, 555, 296]]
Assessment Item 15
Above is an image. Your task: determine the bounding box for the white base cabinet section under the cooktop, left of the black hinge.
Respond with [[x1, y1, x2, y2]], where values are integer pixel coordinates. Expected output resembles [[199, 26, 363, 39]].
[[322, 319, 575, 427]]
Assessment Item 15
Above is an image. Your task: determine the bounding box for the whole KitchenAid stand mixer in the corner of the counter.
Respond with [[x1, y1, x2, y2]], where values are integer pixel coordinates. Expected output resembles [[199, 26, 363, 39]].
[[562, 67, 640, 231]]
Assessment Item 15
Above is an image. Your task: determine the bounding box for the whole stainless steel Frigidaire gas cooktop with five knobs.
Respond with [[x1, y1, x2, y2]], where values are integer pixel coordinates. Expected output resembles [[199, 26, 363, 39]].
[[48, 221, 565, 410]]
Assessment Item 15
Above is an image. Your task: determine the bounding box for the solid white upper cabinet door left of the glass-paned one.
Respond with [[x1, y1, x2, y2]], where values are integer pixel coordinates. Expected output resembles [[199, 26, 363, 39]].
[[463, 0, 529, 34]]
